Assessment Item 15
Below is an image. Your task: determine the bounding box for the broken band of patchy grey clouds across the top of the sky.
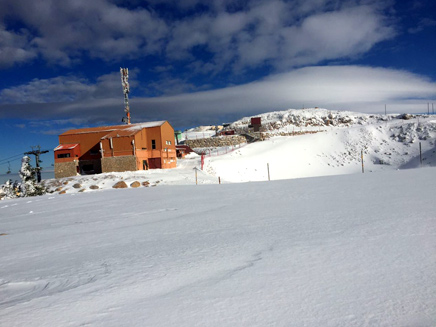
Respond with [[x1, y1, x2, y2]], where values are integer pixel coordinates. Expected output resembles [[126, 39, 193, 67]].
[[0, 0, 395, 73]]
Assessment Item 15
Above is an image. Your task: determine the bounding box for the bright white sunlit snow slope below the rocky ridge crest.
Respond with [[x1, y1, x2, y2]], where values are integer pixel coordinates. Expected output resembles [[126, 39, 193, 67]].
[[206, 120, 436, 182]]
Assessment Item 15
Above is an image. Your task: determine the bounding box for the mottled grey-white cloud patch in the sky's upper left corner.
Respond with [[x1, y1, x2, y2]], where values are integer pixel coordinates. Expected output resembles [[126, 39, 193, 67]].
[[0, 0, 168, 65]]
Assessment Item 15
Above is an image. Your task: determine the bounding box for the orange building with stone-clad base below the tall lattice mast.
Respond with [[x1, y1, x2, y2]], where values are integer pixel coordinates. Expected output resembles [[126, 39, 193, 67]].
[[54, 121, 176, 178]]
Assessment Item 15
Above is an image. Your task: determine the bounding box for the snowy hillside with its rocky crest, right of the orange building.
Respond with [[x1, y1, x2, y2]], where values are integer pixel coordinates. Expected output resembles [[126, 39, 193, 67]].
[[206, 109, 436, 182]]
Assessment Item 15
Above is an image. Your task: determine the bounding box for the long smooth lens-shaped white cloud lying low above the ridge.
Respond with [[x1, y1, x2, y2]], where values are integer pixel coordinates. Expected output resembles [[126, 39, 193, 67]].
[[0, 66, 436, 127]]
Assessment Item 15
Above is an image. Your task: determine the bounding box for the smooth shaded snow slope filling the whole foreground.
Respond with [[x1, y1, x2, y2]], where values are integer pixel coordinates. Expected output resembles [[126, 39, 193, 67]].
[[0, 168, 436, 327]]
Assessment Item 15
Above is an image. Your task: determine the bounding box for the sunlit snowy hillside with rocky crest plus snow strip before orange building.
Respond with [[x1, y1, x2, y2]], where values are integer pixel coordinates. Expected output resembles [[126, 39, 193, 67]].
[[0, 109, 436, 193]]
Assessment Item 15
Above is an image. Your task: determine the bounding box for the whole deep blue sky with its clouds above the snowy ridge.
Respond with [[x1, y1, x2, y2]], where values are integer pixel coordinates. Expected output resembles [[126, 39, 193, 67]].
[[0, 0, 436, 173]]
